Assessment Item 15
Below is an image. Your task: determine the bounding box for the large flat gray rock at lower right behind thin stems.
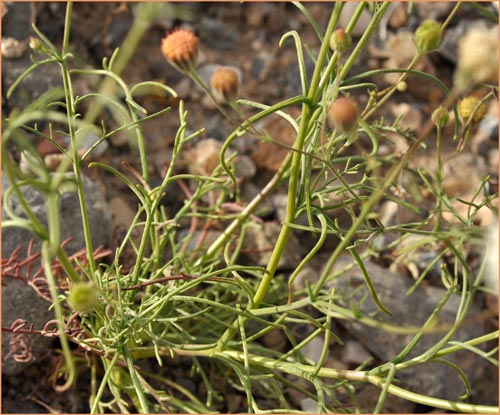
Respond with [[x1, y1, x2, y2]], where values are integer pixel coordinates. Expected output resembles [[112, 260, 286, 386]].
[[324, 256, 493, 400]]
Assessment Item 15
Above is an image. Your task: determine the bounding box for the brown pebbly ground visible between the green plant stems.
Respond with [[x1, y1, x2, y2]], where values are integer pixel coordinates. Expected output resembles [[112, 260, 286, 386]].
[[2, 2, 498, 413]]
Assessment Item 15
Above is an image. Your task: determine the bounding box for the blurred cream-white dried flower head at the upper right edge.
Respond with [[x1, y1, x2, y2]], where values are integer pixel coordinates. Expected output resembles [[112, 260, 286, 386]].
[[455, 25, 498, 92]]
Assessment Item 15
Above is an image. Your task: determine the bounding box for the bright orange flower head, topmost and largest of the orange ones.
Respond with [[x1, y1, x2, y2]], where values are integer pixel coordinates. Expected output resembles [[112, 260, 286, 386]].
[[161, 29, 199, 71]]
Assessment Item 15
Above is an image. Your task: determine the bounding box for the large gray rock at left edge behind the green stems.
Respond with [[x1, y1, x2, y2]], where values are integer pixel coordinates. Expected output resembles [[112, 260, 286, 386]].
[[2, 173, 111, 375]]
